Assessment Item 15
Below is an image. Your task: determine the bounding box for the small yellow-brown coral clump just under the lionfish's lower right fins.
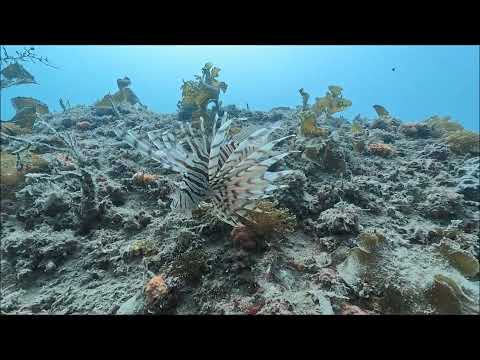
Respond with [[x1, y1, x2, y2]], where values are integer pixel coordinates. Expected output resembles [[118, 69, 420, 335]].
[[247, 201, 297, 235]]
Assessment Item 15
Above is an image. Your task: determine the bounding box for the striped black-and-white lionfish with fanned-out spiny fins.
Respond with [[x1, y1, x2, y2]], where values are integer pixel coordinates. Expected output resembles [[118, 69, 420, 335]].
[[118, 112, 297, 226]]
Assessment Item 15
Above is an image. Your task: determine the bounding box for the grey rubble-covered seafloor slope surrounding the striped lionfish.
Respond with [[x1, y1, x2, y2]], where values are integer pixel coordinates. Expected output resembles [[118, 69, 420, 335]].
[[0, 99, 480, 315]]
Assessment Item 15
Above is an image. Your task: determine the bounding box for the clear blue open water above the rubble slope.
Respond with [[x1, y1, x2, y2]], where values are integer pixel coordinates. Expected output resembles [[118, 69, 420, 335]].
[[1, 45, 480, 131]]
